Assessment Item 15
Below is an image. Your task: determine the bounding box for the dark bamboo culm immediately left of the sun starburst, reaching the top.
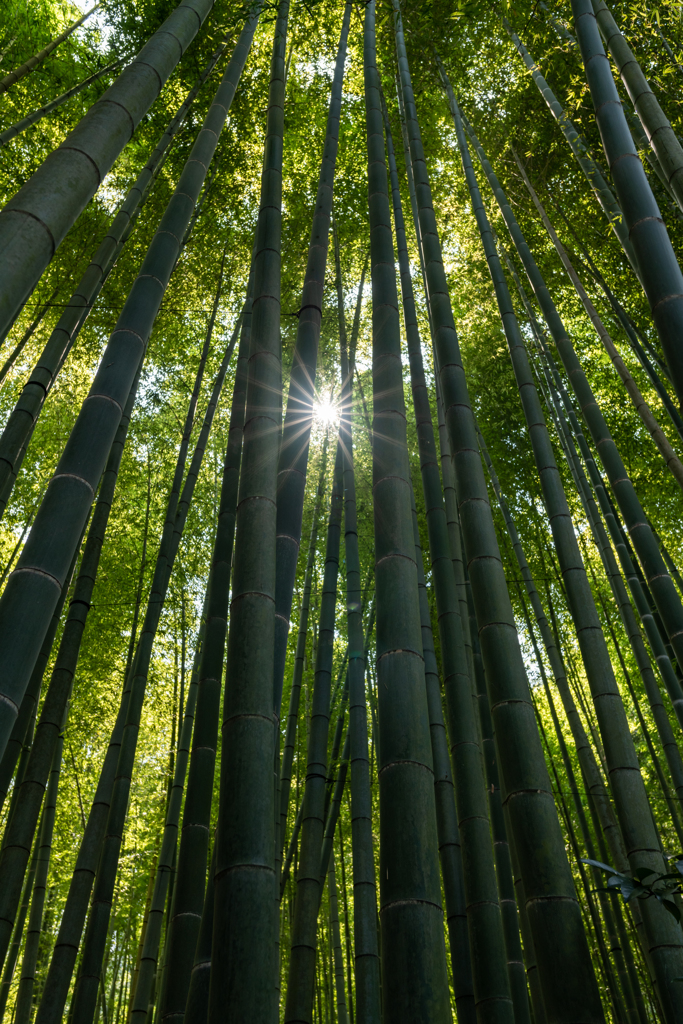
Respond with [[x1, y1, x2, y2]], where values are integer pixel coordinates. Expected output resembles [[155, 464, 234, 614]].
[[273, 2, 352, 724]]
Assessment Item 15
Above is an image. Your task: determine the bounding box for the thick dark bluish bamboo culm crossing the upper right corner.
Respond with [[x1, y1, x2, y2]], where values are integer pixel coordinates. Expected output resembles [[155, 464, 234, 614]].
[[571, 0, 683, 403]]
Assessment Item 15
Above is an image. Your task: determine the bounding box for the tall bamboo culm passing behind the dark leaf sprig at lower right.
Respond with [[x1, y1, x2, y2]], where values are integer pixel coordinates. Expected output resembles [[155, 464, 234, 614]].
[[442, 86, 683, 1019]]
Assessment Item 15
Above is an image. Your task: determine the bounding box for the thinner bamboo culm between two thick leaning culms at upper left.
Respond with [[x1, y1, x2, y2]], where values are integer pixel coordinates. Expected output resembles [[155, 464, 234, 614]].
[[0, 34, 227, 516]]
